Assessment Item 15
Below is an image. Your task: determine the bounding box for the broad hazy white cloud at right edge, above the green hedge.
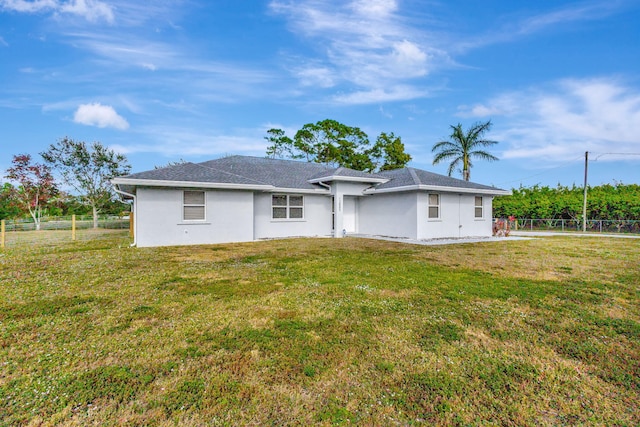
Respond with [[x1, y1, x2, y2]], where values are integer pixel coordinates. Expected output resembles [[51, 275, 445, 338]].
[[462, 78, 640, 163]]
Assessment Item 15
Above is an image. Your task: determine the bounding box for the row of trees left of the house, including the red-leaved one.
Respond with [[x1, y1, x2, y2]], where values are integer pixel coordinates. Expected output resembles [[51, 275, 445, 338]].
[[0, 138, 131, 230]]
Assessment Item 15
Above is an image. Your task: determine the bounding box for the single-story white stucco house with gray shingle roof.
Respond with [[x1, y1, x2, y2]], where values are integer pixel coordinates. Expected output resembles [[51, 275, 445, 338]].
[[112, 156, 510, 247]]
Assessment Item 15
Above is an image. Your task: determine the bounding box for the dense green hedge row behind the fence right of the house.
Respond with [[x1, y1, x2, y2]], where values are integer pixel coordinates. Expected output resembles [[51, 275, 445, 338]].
[[493, 183, 640, 220]]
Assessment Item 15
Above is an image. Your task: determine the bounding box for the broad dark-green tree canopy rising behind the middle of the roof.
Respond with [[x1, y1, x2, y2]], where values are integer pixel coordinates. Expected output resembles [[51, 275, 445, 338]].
[[265, 119, 411, 172]]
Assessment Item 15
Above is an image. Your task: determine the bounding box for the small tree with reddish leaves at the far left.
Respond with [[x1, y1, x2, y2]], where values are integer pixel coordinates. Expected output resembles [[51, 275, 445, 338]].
[[6, 154, 57, 230]]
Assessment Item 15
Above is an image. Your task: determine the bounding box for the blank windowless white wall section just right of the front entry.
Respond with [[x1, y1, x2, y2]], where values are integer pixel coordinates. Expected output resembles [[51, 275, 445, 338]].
[[358, 191, 419, 239]]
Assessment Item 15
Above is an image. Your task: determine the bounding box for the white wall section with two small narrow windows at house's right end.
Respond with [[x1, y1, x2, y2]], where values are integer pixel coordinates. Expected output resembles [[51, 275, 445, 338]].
[[418, 192, 492, 239]]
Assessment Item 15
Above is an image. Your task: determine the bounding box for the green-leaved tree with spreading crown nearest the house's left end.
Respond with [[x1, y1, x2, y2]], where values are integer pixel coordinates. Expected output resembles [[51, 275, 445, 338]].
[[41, 138, 131, 228]]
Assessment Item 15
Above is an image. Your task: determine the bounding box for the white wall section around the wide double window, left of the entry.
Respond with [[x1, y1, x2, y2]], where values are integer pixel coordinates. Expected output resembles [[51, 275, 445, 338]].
[[254, 193, 331, 239]]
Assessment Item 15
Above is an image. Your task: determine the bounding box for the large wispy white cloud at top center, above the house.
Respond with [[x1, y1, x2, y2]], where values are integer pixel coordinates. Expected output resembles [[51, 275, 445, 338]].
[[270, 0, 442, 104]]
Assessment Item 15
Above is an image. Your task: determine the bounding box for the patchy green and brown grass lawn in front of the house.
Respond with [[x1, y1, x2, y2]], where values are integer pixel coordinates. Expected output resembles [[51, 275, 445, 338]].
[[0, 232, 640, 426]]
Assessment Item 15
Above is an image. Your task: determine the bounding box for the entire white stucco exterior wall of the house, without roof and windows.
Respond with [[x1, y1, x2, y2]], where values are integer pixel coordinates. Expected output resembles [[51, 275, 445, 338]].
[[135, 183, 493, 247]]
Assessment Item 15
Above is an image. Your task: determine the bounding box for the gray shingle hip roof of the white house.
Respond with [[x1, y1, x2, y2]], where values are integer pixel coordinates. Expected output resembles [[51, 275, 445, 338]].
[[115, 156, 500, 191]]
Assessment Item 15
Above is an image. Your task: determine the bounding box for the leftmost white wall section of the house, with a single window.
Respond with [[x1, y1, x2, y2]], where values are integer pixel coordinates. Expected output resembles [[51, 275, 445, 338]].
[[135, 188, 253, 247]]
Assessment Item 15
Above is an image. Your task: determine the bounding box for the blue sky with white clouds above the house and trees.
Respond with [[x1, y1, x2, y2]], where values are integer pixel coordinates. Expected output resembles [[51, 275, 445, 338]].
[[0, 0, 640, 188]]
